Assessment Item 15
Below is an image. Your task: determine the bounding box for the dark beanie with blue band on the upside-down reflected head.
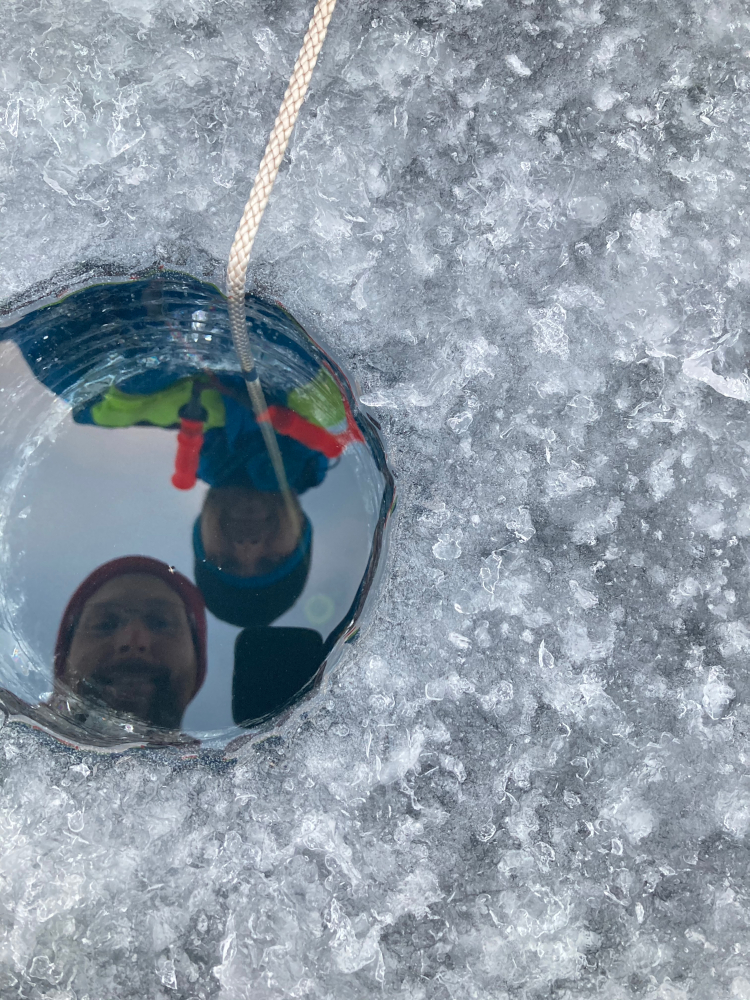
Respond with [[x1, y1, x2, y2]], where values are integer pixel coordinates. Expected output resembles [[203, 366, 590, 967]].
[[193, 517, 312, 628]]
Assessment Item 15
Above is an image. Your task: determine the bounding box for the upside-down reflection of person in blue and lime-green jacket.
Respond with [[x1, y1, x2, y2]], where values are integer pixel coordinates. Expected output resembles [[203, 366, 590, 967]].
[[2, 274, 362, 627]]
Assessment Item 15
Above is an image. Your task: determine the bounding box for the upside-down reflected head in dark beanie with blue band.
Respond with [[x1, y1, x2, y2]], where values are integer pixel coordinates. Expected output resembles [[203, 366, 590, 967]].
[[193, 485, 312, 626]]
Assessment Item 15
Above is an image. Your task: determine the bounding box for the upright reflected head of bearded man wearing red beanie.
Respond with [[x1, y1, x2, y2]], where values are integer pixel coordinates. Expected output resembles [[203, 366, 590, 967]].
[[55, 556, 206, 729]]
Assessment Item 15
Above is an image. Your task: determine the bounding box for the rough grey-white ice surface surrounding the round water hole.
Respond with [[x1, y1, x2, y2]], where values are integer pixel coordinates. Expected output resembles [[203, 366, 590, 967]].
[[0, 0, 750, 1000]]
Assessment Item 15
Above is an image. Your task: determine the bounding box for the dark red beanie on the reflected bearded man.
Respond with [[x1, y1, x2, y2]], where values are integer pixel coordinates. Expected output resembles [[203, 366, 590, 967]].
[[55, 556, 207, 697]]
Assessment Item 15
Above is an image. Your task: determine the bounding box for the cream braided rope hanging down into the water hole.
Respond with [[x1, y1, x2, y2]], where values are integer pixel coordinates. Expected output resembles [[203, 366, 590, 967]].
[[227, 0, 336, 524]]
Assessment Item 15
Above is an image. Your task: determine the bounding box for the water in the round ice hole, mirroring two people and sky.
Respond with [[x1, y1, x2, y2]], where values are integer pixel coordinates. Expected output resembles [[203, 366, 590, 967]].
[[0, 275, 392, 743]]
